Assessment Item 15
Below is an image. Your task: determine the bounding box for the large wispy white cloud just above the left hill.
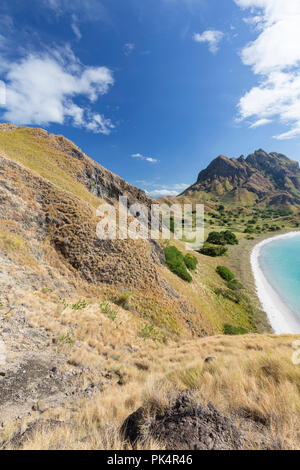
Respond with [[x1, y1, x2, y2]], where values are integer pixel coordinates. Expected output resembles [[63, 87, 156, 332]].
[[1, 49, 114, 134]]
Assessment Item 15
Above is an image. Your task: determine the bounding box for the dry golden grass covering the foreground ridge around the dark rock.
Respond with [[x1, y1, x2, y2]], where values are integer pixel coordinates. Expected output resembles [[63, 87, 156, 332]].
[[5, 294, 300, 450]]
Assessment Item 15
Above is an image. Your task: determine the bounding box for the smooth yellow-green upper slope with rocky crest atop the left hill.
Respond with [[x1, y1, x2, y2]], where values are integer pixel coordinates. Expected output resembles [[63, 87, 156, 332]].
[[0, 124, 151, 207]]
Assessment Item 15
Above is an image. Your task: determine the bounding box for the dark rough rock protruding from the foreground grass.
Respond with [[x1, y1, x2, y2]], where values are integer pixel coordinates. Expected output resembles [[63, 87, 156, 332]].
[[121, 392, 243, 450]]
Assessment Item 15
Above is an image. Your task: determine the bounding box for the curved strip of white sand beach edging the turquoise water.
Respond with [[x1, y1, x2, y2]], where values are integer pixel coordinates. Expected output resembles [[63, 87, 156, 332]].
[[250, 231, 300, 334]]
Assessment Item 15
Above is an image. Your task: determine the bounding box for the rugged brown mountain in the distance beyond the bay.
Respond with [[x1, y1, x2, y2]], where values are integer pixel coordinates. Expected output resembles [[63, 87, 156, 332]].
[[181, 149, 300, 209]]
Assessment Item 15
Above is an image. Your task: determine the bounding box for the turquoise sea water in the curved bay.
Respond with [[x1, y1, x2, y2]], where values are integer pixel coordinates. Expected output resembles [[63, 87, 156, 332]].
[[259, 235, 300, 321]]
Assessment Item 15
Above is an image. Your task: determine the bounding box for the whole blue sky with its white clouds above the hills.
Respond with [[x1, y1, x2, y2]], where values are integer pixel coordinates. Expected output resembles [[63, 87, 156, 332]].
[[0, 0, 300, 196]]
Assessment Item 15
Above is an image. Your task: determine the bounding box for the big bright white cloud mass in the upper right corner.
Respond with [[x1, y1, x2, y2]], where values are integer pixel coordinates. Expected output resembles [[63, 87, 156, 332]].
[[234, 0, 300, 140]]
